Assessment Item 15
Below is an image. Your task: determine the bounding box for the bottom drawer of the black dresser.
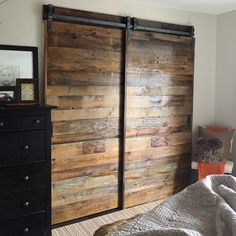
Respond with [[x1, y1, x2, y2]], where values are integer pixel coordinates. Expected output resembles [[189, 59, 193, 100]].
[[0, 213, 46, 236]]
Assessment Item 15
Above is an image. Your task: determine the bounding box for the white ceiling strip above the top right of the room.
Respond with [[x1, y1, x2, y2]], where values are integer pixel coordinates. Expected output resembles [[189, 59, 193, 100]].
[[134, 0, 236, 14]]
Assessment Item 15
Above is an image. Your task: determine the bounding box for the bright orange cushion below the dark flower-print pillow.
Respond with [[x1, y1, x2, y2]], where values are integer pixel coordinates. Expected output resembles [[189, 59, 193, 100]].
[[198, 161, 225, 180]]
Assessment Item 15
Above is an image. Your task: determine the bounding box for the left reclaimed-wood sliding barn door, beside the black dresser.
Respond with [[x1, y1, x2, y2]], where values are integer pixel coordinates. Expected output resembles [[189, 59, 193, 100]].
[[45, 22, 124, 224]]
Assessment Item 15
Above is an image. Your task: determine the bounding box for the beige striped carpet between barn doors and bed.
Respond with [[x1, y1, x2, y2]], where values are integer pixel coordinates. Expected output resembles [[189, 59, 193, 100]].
[[52, 200, 163, 236]]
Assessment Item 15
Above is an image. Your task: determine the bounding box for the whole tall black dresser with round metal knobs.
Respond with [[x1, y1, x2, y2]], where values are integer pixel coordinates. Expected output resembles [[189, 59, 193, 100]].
[[0, 106, 52, 236]]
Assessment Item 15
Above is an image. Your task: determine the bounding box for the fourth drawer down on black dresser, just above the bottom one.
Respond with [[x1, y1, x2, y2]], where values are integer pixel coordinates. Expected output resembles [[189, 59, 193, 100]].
[[0, 188, 46, 221]]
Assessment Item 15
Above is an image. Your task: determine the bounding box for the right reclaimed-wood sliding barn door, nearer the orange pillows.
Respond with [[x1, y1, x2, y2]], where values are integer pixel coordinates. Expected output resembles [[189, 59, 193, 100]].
[[124, 31, 194, 207]]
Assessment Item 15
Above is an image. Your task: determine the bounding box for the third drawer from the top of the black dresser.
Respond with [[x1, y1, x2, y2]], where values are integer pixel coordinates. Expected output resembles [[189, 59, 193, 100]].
[[0, 162, 50, 193]]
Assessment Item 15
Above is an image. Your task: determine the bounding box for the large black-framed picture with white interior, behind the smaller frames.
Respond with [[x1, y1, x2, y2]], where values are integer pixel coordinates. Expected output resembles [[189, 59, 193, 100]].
[[0, 45, 38, 88]]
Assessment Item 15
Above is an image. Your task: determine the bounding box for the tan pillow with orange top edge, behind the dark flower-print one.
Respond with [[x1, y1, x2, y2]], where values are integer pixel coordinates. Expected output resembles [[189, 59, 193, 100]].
[[199, 126, 235, 160]]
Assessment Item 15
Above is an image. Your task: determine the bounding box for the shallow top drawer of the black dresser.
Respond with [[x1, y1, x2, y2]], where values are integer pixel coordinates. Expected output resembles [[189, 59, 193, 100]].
[[0, 116, 46, 132]]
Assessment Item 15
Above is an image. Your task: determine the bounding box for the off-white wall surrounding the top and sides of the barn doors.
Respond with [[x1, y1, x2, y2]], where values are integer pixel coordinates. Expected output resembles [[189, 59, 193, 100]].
[[0, 0, 217, 131]]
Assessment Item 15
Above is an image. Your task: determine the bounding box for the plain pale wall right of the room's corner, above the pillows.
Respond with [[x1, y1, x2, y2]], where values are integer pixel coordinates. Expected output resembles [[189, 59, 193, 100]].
[[215, 11, 236, 175]]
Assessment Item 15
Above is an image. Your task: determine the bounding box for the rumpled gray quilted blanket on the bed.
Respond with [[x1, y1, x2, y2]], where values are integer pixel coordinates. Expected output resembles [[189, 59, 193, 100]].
[[109, 175, 236, 236]]
